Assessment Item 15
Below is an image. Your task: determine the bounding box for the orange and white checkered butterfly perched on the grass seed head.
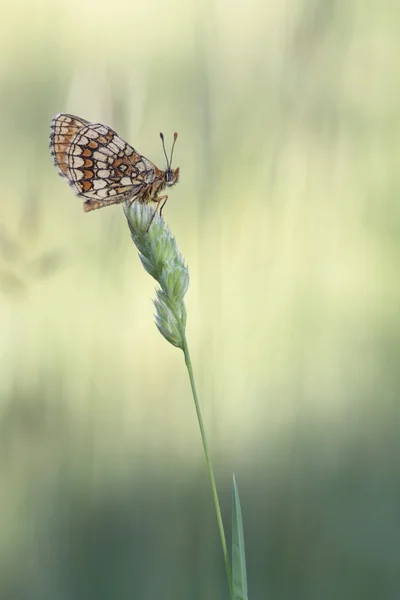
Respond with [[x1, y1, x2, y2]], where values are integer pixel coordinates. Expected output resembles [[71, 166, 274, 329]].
[[50, 113, 179, 214]]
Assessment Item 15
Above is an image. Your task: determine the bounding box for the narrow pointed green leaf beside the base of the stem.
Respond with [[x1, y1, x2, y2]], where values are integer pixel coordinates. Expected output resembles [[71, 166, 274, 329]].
[[232, 475, 248, 600]]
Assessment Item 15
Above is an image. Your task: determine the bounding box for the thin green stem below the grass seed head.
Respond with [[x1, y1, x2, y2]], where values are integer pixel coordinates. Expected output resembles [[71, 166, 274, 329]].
[[182, 332, 233, 600]]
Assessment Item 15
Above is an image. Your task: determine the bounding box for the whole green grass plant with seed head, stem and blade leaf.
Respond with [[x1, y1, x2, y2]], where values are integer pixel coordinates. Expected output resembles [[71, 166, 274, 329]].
[[125, 202, 248, 600]]
